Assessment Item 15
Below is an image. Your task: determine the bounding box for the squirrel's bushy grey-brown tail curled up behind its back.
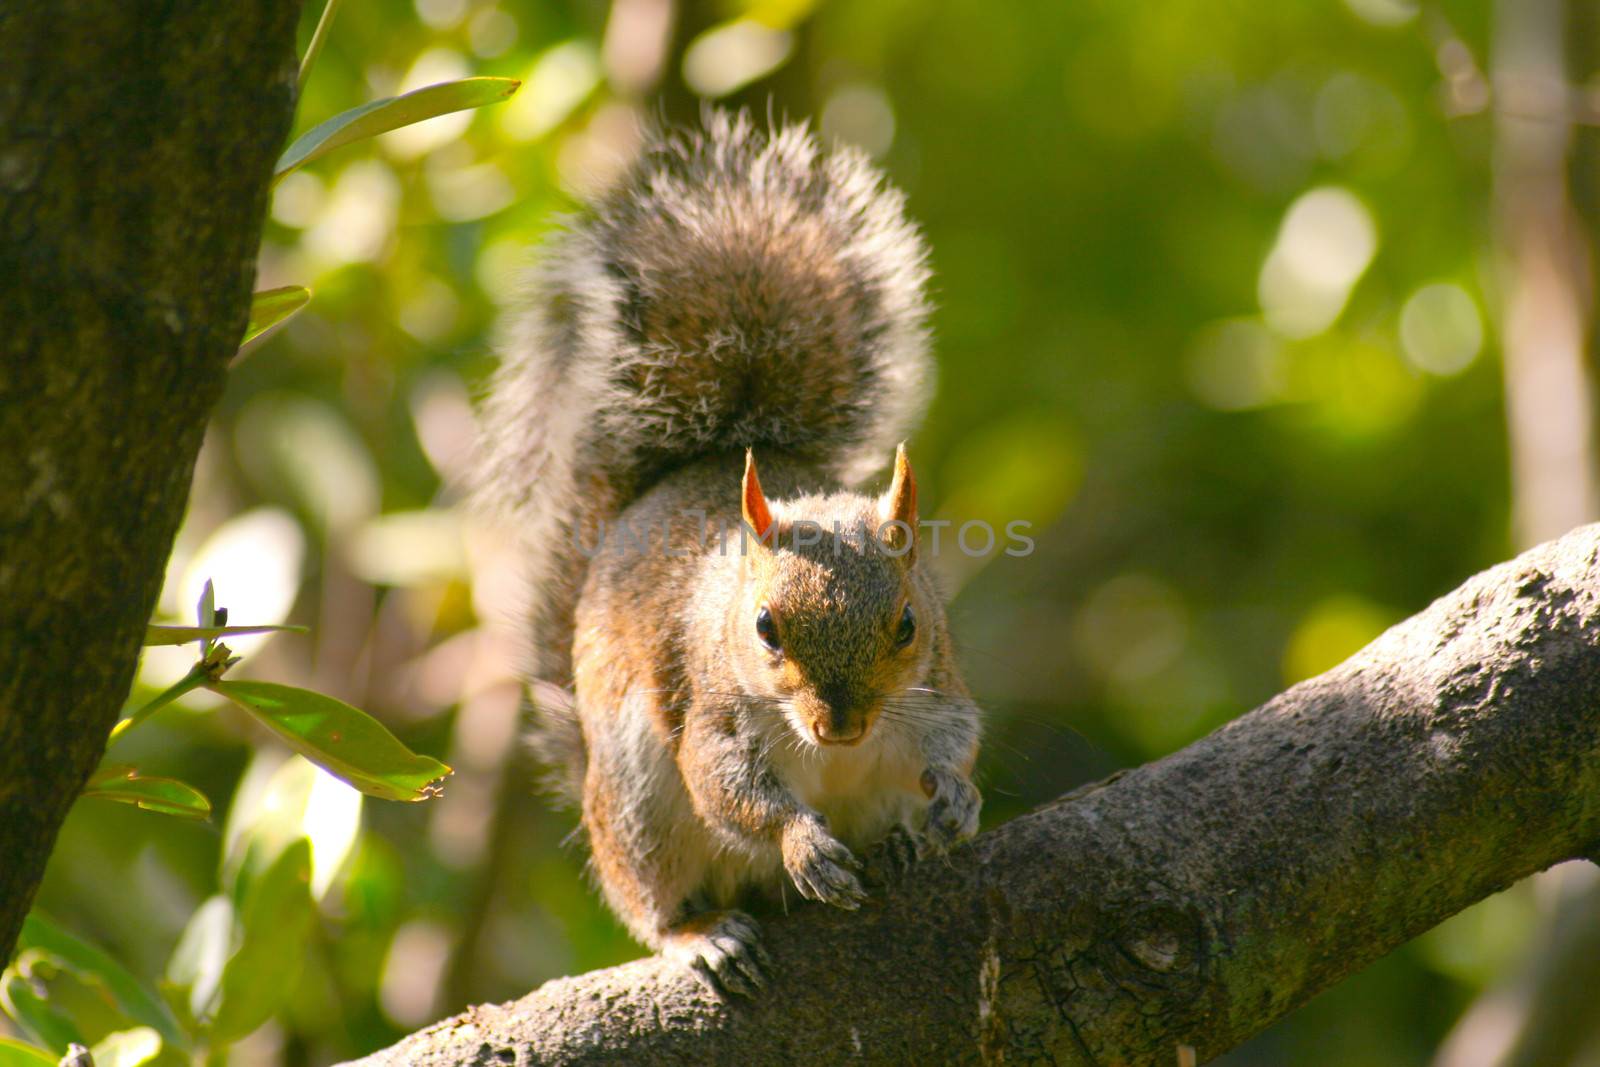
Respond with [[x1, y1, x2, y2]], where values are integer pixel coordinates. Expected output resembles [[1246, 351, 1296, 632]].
[[478, 112, 931, 796]]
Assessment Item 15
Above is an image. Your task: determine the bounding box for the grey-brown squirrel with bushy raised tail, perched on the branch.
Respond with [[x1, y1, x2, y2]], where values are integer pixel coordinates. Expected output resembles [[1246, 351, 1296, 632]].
[[478, 112, 981, 995]]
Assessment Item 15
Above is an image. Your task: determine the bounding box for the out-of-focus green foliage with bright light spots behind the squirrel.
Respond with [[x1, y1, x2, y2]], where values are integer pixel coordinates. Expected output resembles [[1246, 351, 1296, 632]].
[[9, 0, 1587, 1065]]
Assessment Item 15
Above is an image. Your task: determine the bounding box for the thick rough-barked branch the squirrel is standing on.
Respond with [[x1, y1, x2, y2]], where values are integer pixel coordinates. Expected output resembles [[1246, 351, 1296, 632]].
[[358, 525, 1600, 1067]]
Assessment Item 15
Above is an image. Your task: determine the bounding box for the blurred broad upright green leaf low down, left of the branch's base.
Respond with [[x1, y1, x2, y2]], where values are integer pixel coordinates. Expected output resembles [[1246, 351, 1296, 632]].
[[211, 838, 317, 1041]]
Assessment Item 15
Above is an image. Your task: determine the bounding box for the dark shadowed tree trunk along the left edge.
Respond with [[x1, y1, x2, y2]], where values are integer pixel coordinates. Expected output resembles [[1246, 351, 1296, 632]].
[[0, 0, 299, 960]]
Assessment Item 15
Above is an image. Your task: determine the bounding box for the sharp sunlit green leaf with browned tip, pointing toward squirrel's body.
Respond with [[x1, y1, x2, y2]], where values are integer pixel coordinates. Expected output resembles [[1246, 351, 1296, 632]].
[[206, 681, 451, 800]]
